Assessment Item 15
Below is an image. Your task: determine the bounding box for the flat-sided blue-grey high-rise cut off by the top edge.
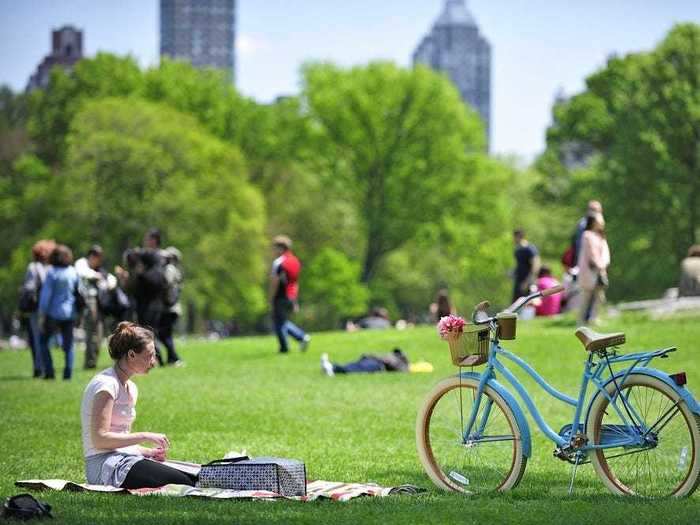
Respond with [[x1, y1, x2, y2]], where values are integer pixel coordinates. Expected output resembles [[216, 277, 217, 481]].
[[160, 0, 236, 79]]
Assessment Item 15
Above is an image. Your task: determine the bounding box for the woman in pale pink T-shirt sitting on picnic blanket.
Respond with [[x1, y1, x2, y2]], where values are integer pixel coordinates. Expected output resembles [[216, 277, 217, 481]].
[[80, 322, 196, 489]]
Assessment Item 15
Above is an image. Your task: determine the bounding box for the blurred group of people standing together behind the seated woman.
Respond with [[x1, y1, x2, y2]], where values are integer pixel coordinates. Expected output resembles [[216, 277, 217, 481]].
[[19, 229, 183, 380]]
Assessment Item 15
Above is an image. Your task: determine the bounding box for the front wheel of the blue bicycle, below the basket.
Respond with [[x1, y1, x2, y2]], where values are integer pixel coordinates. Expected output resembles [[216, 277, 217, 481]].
[[416, 377, 527, 494]]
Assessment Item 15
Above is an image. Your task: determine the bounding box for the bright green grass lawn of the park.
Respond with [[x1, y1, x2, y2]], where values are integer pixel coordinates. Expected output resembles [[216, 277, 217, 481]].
[[0, 317, 700, 524]]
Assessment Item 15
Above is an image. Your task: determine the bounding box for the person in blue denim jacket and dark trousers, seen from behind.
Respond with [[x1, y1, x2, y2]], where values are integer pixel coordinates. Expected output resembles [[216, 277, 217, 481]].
[[39, 244, 78, 381]]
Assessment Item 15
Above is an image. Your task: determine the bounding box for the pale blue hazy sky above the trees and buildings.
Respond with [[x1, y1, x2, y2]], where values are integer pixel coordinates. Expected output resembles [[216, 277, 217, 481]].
[[0, 0, 700, 160]]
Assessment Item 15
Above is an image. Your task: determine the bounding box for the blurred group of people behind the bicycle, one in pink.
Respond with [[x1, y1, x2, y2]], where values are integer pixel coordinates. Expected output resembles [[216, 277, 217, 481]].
[[512, 200, 610, 325]]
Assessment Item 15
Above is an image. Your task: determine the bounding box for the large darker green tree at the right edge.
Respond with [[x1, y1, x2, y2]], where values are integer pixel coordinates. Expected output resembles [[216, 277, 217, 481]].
[[541, 24, 700, 297]]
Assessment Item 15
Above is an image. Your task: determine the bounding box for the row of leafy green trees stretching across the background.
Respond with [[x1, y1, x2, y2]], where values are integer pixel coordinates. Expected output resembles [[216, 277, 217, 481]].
[[0, 24, 700, 330]]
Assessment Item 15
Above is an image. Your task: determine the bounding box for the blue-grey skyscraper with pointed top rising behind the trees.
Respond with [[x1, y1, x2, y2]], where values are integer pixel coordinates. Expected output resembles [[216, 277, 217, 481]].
[[413, 0, 491, 146]]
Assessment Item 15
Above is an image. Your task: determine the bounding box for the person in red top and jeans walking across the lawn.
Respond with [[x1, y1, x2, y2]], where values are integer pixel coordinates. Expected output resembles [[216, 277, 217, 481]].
[[268, 235, 311, 354]]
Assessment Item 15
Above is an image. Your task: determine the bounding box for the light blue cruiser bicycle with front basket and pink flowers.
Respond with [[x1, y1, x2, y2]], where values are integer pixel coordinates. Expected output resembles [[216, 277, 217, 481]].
[[416, 287, 700, 497]]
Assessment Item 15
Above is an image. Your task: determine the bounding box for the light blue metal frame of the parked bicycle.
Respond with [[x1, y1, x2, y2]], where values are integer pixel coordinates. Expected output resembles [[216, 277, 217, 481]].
[[463, 334, 675, 452]]
